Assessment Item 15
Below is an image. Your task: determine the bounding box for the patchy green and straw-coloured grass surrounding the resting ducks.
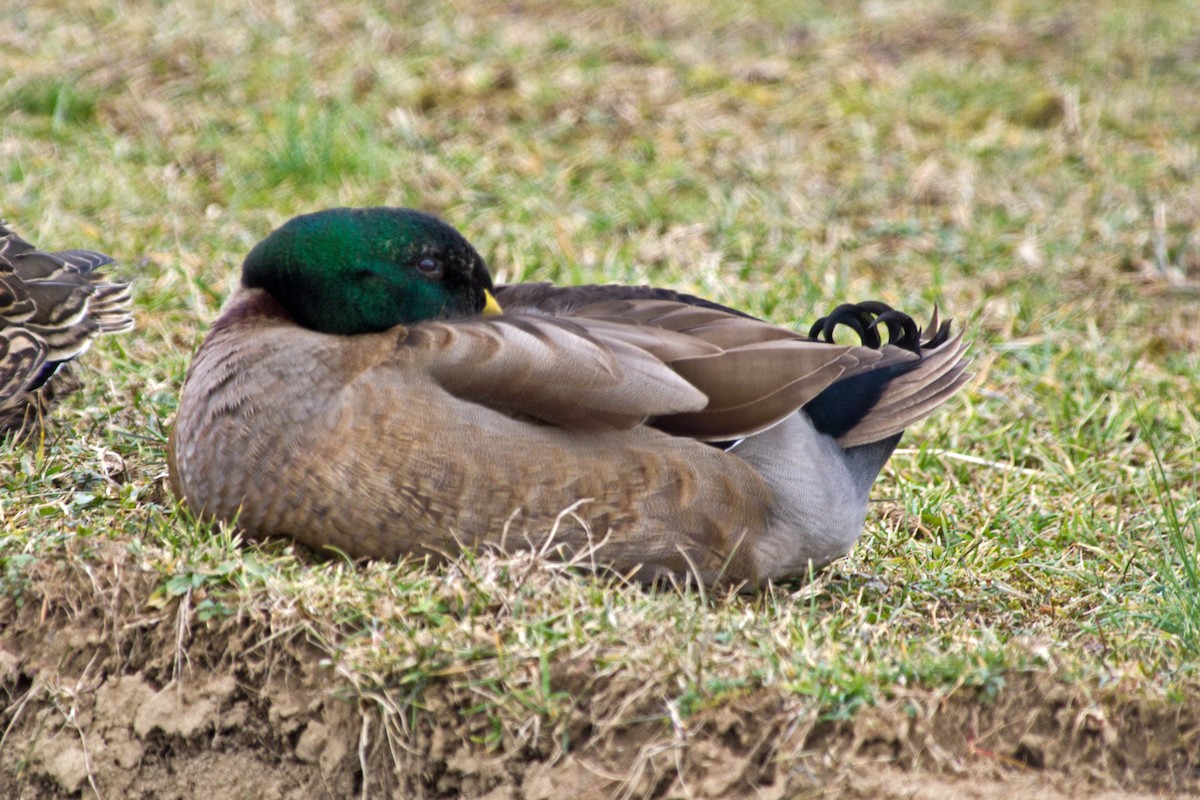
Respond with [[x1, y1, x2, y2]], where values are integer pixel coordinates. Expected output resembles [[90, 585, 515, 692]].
[[0, 0, 1200, 777]]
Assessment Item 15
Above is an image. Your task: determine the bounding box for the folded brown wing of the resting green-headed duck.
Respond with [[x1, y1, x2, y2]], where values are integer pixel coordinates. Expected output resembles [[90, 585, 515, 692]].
[[412, 293, 902, 440]]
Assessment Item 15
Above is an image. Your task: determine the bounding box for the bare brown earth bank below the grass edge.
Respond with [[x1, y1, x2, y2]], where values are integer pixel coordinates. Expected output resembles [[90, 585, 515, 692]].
[[0, 548, 1200, 800]]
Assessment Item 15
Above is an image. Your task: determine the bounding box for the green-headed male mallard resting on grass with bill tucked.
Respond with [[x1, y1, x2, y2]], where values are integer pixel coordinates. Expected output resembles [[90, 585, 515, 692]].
[[168, 209, 967, 584]]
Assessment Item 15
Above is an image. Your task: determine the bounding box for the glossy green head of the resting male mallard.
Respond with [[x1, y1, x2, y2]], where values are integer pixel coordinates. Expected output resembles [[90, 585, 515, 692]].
[[241, 207, 498, 335]]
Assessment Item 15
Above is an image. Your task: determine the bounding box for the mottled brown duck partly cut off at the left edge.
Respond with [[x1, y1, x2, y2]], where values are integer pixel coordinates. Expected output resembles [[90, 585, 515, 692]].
[[0, 225, 133, 433]]
